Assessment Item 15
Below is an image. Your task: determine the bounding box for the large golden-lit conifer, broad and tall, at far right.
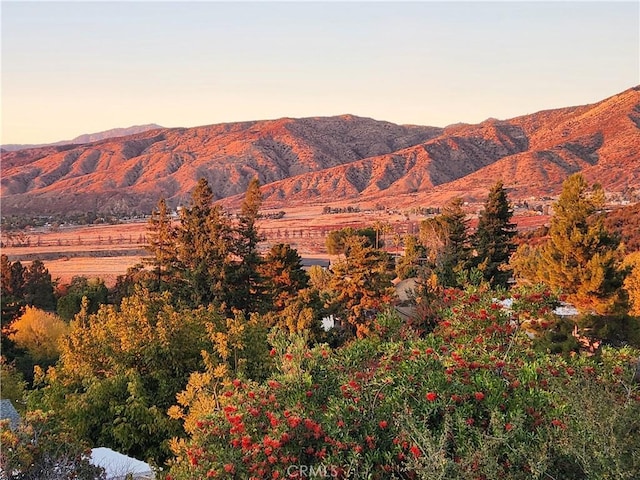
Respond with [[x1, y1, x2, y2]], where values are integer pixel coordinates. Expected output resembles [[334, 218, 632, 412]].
[[539, 173, 624, 313]]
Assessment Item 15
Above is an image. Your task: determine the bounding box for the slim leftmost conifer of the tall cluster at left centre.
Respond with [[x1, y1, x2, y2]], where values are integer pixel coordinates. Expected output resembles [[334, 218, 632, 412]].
[[146, 198, 177, 291]]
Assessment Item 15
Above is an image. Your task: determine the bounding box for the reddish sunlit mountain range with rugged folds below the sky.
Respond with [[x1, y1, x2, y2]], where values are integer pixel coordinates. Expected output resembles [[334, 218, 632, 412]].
[[1, 87, 640, 214]]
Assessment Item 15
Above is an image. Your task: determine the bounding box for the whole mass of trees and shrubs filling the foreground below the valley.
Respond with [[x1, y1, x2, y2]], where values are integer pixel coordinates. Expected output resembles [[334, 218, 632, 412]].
[[0, 175, 640, 480]]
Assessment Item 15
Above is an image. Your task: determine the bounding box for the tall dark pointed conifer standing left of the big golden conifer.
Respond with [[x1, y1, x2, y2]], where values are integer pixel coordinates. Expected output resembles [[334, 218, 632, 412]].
[[471, 181, 516, 287]]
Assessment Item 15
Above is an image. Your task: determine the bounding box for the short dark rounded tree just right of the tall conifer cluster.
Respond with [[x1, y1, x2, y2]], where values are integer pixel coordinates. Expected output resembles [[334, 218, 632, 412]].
[[260, 243, 309, 310]]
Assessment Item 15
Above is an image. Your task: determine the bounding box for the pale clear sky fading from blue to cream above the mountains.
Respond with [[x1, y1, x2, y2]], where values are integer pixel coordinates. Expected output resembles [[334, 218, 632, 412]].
[[0, 0, 640, 144]]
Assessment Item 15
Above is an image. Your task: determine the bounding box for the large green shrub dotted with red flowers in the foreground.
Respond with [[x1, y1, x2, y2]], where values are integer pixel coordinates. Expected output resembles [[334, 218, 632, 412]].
[[171, 292, 640, 479]]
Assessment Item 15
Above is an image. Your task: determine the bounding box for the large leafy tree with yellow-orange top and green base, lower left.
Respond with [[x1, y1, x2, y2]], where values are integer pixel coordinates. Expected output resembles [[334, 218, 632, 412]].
[[30, 290, 211, 462]]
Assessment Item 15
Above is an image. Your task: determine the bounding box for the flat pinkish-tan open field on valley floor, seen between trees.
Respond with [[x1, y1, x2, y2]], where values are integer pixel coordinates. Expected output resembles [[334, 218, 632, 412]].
[[2, 206, 548, 285]]
